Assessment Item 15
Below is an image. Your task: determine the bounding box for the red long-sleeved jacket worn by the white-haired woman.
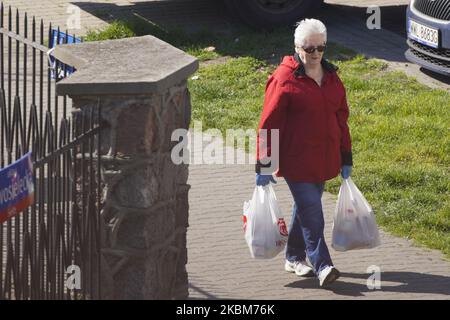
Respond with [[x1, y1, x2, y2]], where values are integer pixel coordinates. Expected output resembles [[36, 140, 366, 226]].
[[256, 55, 352, 183]]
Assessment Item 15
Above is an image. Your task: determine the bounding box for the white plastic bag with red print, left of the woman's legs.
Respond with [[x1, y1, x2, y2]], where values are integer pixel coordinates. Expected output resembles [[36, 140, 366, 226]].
[[243, 184, 288, 259]]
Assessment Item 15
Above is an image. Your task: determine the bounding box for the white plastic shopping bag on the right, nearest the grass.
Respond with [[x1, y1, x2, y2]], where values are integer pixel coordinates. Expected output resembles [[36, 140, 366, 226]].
[[331, 178, 380, 251]]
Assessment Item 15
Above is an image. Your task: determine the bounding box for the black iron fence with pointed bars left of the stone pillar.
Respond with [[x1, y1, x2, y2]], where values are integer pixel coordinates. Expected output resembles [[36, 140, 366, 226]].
[[0, 4, 101, 299]]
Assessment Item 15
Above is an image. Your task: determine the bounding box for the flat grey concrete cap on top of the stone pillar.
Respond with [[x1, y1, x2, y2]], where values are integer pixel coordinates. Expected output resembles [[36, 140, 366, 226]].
[[53, 35, 198, 96]]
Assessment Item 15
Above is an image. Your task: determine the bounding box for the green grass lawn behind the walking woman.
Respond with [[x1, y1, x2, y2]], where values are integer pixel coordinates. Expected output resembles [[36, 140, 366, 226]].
[[88, 20, 450, 257]]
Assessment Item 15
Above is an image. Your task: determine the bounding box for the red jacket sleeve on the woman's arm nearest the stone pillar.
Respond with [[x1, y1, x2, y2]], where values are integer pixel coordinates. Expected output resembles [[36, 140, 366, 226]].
[[255, 76, 289, 173]]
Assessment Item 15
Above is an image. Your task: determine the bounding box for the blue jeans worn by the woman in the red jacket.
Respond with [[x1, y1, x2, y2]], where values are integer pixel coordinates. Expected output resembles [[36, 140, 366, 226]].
[[286, 179, 333, 274]]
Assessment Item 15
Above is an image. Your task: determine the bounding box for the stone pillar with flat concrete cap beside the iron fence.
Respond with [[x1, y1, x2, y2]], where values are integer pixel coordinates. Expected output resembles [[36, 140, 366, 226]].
[[54, 36, 198, 299]]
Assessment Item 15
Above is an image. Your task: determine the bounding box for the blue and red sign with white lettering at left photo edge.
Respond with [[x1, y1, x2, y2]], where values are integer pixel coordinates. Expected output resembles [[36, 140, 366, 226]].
[[0, 152, 34, 223]]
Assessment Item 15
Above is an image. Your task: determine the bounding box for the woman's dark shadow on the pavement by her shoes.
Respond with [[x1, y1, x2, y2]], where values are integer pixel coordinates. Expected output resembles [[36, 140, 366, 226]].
[[285, 272, 450, 297]]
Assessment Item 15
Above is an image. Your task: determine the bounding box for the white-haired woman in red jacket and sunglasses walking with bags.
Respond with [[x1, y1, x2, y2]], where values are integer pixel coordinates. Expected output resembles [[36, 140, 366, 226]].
[[256, 19, 352, 286]]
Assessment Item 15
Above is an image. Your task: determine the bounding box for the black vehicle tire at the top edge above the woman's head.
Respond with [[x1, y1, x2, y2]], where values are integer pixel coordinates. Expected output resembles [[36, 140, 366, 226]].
[[225, 0, 323, 29]]
